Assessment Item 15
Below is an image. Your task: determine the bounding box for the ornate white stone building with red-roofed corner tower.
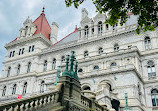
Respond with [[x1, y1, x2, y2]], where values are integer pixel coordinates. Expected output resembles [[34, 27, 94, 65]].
[[0, 9, 158, 111]]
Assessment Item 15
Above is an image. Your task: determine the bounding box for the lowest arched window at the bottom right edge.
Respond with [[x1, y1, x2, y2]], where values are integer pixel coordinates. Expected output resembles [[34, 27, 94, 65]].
[[151, 89, 158, 106]]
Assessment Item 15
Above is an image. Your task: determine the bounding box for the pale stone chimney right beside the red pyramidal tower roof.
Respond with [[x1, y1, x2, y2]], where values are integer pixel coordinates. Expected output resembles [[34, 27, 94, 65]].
[[50, 22, 59, 44]]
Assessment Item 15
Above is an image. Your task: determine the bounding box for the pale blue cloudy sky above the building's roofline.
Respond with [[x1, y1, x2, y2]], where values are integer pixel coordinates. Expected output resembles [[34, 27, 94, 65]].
[[0, 0, 96, 75]]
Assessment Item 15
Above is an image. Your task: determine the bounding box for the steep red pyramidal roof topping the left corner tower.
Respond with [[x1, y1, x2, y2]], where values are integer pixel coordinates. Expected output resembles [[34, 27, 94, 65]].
[[33, 11, 51, 40]]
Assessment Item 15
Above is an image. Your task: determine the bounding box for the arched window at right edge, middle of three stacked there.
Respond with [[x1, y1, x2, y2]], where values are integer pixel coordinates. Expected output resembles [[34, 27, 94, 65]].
[[147, 61, 156, 79]]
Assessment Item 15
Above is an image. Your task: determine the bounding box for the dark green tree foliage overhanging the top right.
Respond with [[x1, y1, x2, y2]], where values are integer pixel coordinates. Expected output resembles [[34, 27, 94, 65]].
[[65, 0, 158, 34]]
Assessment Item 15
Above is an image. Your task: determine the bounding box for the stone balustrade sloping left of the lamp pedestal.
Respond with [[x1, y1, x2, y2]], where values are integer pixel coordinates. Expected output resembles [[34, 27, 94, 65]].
[[0, 90, 59, 111]]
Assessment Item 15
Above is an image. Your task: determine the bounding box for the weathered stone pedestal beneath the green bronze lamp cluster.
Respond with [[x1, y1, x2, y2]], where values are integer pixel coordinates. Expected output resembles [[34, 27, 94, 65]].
[[58, 76, 84, 111]]
